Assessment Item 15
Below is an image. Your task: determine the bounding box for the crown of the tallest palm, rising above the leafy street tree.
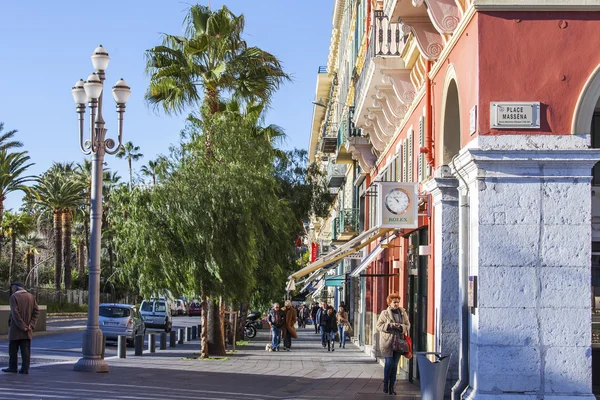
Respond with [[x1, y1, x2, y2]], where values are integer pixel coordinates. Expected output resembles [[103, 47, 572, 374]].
[[146, 5, 290, 114]]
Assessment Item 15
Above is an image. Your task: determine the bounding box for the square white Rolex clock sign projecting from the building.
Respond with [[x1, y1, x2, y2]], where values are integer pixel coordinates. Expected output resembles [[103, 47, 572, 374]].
[[377, 182, 419, 229]]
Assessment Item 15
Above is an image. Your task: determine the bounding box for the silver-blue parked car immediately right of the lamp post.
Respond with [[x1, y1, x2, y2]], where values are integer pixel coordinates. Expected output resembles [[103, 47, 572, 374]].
[[98, 303, 146, 346]]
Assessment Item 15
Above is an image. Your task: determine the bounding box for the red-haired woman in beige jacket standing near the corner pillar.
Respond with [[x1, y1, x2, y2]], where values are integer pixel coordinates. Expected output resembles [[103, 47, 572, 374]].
[[377, 293, 410, 394]]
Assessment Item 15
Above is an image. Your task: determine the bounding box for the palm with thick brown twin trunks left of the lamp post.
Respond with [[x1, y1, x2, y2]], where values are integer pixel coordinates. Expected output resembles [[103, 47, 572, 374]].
[[33, 174, 84, 290]]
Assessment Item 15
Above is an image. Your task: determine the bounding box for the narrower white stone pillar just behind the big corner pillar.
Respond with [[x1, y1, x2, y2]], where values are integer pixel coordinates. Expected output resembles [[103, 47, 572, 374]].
[[423, 166, 459, 393]]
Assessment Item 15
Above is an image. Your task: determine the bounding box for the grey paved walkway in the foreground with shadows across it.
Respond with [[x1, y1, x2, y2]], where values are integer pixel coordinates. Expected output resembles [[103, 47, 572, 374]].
[[0, 326, 419, 400]]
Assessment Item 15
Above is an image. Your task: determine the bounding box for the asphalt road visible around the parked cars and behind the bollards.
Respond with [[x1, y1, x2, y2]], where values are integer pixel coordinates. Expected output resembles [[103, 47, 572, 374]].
[[0, 316, 200, 366]]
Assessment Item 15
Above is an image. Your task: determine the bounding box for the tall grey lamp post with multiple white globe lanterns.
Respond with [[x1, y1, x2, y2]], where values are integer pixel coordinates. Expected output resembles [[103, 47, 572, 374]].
[[71, 45, 131, 372]]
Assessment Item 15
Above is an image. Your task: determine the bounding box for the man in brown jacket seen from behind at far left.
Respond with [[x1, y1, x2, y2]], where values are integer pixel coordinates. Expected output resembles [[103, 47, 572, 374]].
[[2, 282, 40, 374]]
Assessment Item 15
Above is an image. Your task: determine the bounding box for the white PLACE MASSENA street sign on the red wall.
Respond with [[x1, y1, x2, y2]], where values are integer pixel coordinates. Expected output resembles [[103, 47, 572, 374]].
[[490, 101, 540, 129]]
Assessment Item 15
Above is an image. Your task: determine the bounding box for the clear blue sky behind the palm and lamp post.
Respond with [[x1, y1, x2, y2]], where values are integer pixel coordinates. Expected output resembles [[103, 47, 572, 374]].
[[0, 0, 333, 209]]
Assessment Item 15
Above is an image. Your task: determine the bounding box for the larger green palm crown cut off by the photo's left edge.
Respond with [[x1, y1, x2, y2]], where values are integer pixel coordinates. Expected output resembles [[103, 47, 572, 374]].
[[0, 151, 34, 225]]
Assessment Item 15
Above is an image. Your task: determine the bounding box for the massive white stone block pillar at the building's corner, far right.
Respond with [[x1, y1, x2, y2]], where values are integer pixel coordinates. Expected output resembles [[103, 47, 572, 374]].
[[457, 149, 600, 399]]
